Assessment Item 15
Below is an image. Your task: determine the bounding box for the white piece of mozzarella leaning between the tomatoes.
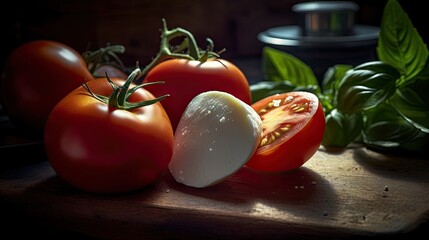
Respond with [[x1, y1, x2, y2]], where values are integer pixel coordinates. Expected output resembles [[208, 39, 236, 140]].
[[169, 91, 262, 188]]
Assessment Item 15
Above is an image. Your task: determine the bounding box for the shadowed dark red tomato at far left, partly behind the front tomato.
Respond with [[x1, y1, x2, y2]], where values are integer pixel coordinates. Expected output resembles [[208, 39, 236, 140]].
[[0, 40, 94, 133]]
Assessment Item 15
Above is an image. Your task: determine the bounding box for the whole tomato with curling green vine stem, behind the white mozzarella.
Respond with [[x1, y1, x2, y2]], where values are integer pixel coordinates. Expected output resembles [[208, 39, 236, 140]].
[[135, 20, 251, 129]]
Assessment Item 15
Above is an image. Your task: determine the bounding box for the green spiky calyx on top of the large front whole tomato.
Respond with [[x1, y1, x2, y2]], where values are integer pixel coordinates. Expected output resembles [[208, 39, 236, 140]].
[[82, 67, 169, 110]]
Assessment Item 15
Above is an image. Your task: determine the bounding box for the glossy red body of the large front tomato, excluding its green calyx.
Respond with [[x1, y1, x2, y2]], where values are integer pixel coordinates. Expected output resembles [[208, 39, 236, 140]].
[[44, 78, 174, 193]]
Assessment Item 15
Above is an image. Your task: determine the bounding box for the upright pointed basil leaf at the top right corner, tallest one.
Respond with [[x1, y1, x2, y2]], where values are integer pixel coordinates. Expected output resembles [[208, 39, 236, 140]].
[[377, 0, 428, 85]]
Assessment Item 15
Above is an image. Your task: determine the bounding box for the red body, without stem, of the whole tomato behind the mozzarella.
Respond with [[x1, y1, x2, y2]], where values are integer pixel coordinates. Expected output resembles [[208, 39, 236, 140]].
[[143, 59, 251, 130]]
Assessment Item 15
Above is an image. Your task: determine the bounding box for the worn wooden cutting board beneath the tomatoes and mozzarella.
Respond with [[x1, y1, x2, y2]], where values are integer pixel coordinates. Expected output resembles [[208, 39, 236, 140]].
[[0, 148, 429, 239]]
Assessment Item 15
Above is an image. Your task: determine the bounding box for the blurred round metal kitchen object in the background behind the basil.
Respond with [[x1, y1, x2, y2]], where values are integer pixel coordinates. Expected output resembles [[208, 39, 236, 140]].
[[258, 1, 380, 81]]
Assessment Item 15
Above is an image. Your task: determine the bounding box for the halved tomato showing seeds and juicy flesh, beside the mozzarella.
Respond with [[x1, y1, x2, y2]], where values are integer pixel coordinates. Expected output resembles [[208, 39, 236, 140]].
[[246, 92, 325, 172]]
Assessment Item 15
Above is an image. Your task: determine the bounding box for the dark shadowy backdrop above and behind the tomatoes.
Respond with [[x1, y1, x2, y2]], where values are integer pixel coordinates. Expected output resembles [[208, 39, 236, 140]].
[[0, 0, 429, 73]]
